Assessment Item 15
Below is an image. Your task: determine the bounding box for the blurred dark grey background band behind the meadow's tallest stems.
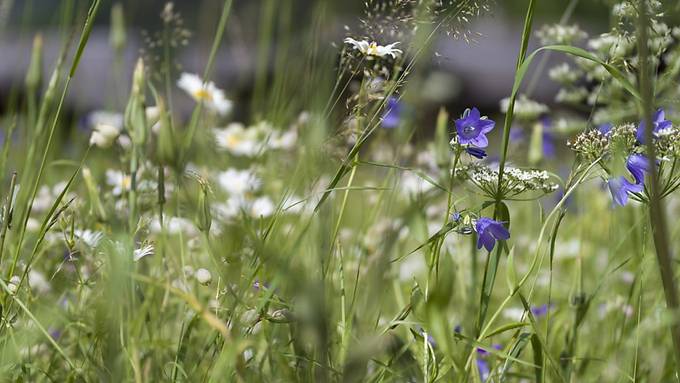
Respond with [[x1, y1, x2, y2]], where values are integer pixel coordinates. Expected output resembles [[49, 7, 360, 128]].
[[0, 0, 609, 118]]
